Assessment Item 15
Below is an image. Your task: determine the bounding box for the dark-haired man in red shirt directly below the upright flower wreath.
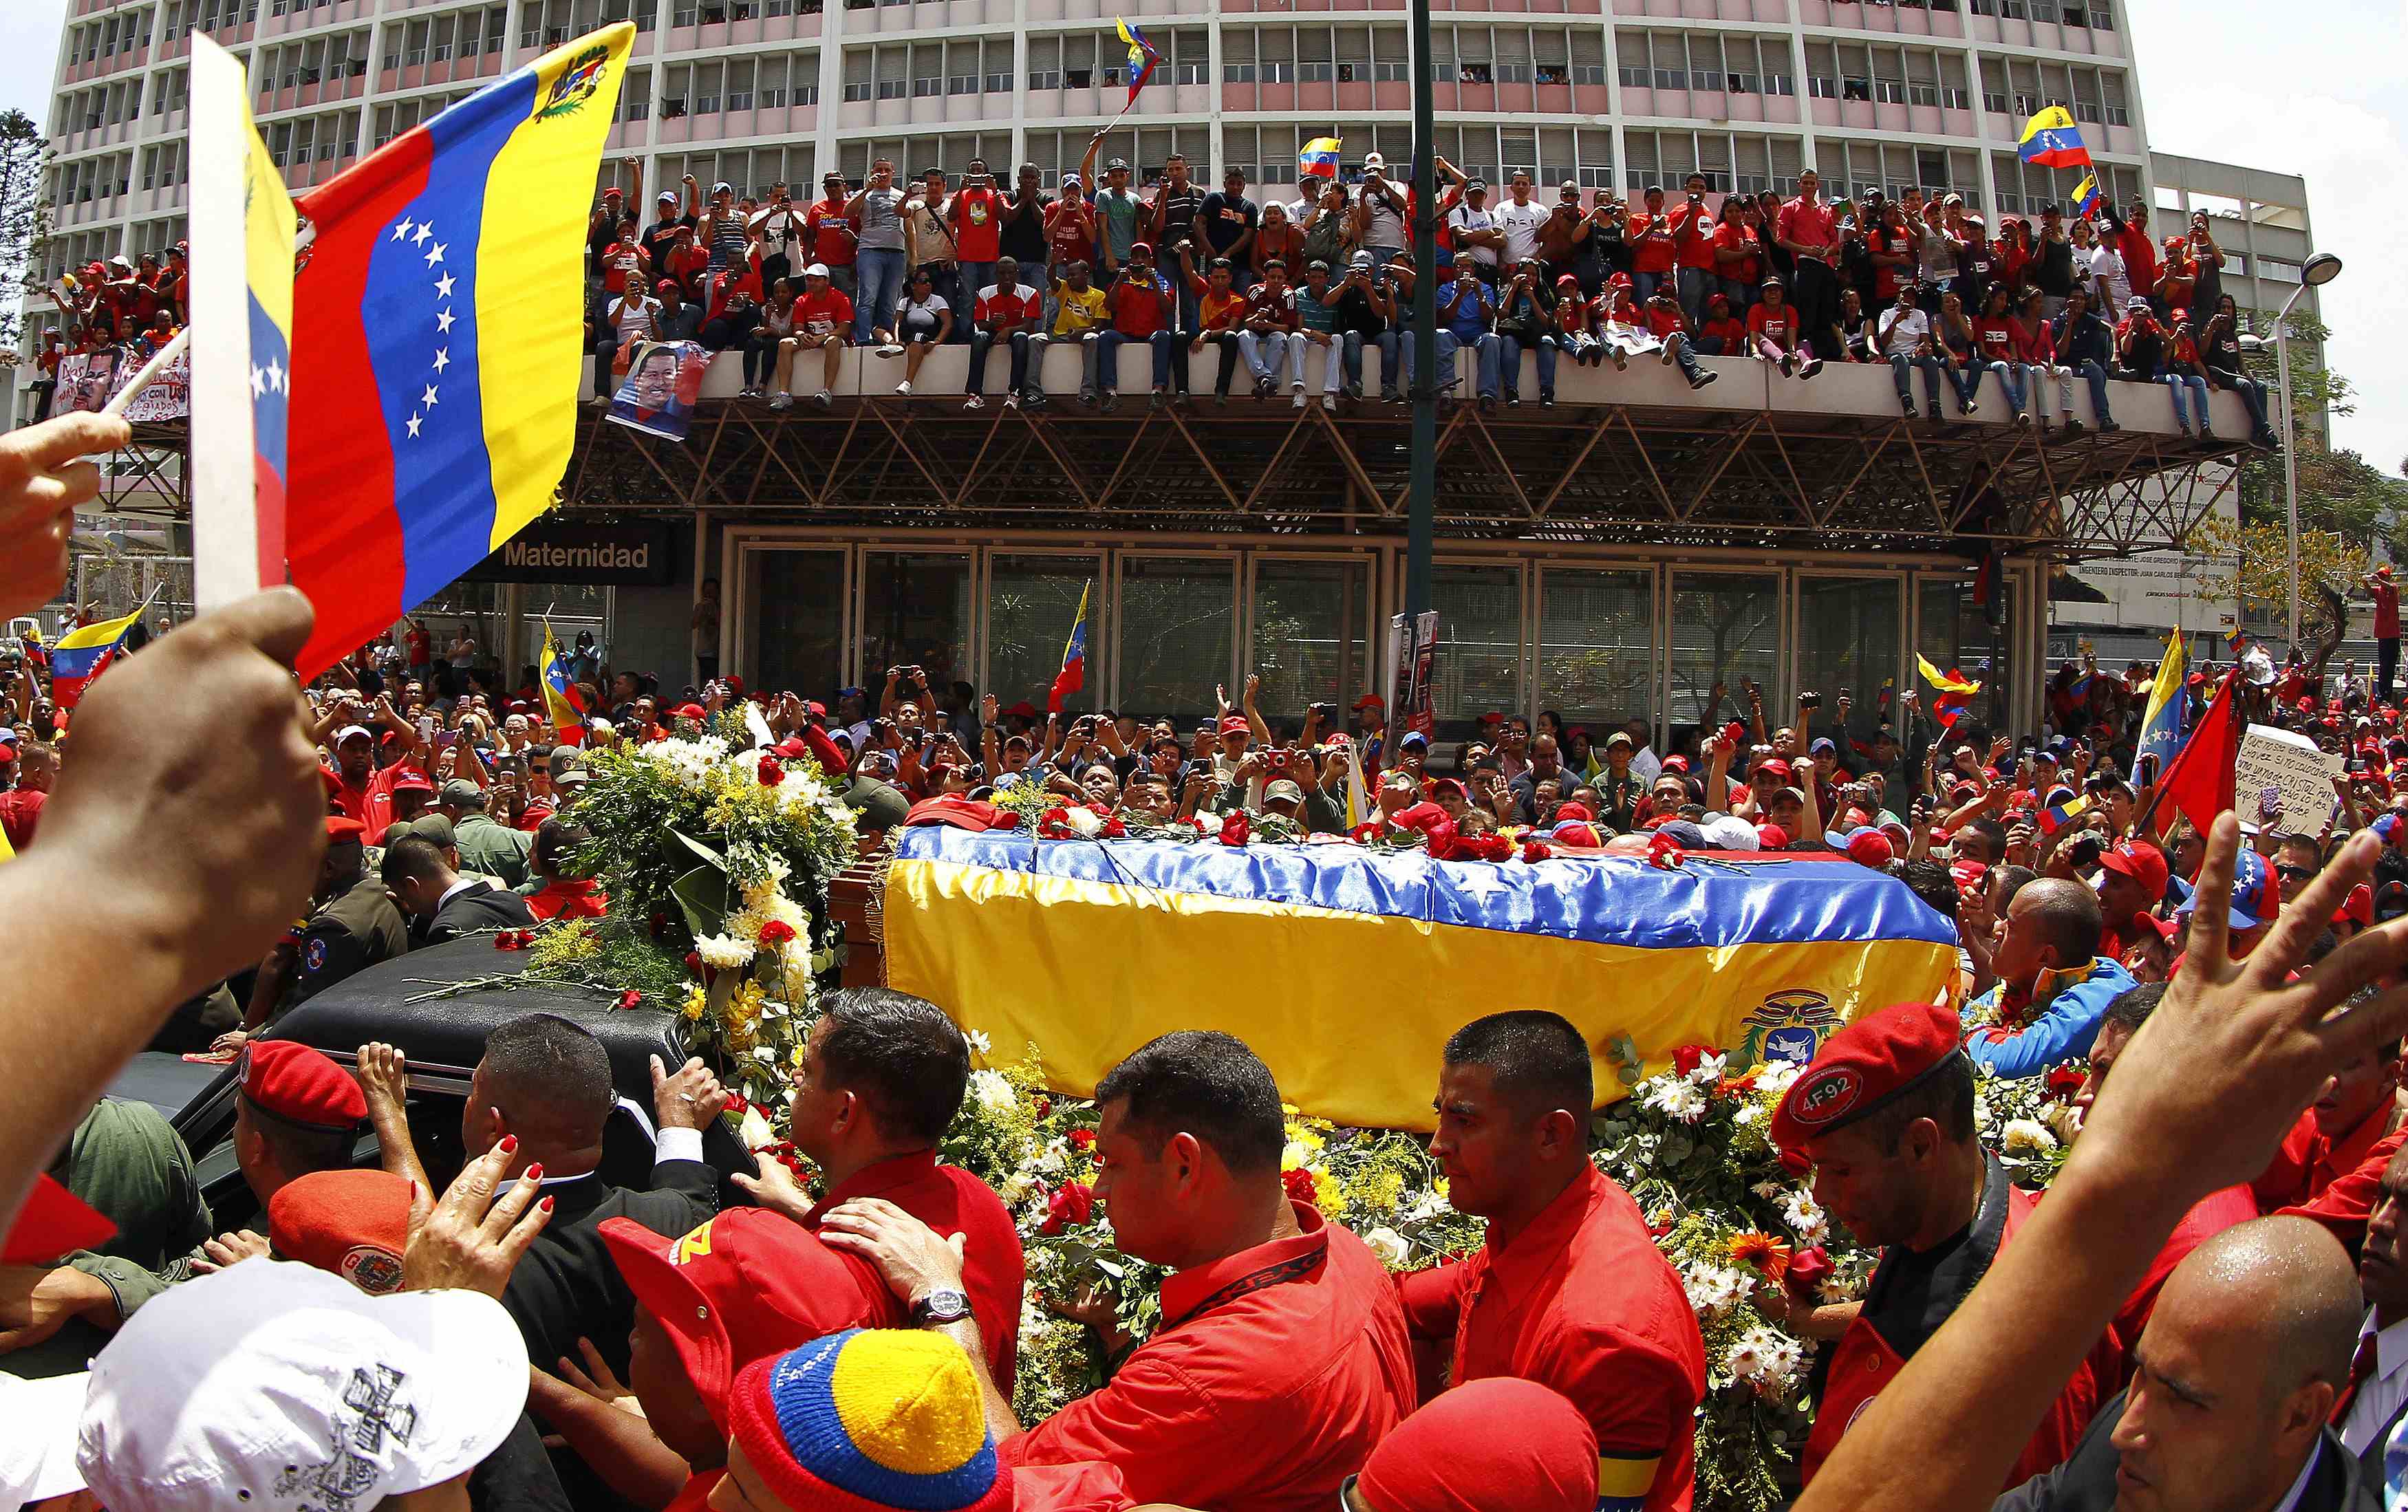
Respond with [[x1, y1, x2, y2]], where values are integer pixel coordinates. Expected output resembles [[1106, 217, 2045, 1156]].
[[735, 987, 1026, 1382]]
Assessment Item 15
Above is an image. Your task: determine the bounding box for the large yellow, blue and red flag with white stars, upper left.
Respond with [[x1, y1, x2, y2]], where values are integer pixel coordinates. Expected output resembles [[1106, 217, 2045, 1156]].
[[287, 22, 636, 677]]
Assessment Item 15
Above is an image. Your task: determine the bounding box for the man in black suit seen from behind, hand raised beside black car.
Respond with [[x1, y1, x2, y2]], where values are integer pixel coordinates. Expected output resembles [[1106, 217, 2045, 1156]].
[[460, 1014, 727, 1380]]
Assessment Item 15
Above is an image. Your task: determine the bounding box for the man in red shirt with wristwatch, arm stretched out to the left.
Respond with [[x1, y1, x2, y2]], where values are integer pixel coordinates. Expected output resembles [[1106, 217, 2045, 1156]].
[[821, 1030, 1414, 1512]]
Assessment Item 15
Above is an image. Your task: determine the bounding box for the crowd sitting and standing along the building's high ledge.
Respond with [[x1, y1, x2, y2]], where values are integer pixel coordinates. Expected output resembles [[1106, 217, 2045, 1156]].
[[588, 149, 2276, 448]]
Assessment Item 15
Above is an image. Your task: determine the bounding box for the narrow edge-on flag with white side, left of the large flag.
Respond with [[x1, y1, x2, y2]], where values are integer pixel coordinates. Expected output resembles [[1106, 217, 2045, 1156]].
[[191, 32, 294, 609]]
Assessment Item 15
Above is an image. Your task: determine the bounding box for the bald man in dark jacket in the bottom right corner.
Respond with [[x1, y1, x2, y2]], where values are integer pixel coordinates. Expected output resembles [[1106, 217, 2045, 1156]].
[[1992, 1218, 2382, 1512]]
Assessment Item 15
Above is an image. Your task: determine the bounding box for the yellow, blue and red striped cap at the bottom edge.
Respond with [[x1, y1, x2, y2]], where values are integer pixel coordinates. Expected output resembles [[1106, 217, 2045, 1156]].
[[722, 1329, 1007, 1512]]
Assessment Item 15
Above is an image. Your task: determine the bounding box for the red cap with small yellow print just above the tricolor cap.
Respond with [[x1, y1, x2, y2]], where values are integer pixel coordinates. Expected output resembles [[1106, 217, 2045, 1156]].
[[602, 1209, 901, 1430]]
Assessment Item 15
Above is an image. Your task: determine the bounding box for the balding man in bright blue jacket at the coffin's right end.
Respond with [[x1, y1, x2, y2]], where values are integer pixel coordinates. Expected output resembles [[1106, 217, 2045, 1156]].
[[1965, 876, 2133, 1077]]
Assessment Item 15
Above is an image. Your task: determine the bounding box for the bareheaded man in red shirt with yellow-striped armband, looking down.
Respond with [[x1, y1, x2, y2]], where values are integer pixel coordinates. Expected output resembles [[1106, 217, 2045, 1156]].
[[1397, 1009, 1705, 1512]]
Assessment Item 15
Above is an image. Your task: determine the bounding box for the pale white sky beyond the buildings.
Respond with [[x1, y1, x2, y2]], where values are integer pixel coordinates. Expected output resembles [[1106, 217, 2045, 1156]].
[[0, 0, 2408, 475]]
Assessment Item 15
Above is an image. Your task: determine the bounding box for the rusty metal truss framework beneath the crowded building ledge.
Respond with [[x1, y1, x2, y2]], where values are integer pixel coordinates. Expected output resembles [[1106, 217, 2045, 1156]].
[[89, 395, 2239, 561]]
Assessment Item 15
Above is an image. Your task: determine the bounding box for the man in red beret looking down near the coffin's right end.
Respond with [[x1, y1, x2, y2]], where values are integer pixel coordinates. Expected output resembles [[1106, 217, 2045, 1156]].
[[1772, 1004, 2122, 1486]]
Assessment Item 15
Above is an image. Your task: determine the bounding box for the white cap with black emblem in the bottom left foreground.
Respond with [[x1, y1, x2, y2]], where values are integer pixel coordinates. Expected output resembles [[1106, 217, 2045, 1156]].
[[77, 1260, 528, 1512]]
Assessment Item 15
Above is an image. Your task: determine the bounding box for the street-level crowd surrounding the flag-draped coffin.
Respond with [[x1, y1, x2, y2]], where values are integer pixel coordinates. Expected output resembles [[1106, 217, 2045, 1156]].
[[0, 400, 2408, 1512]]
